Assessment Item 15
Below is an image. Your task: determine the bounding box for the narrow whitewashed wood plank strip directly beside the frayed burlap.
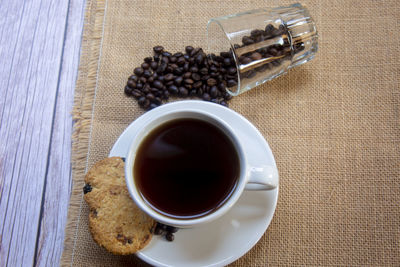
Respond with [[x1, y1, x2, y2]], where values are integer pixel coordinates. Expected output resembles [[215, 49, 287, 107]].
[[35, 0, 85, 266]]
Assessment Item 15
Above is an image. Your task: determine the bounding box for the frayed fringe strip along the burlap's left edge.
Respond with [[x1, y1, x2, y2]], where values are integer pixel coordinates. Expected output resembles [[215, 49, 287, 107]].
[[60, 0, 106, 266]]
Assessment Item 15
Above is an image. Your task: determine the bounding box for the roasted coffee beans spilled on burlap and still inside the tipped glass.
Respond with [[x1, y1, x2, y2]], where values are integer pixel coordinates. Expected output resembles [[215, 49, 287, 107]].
[[124, 24, 304, 110]]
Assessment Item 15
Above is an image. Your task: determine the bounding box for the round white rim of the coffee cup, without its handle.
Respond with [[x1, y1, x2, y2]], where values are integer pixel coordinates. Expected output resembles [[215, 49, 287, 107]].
[[125, 109, 248, 228]]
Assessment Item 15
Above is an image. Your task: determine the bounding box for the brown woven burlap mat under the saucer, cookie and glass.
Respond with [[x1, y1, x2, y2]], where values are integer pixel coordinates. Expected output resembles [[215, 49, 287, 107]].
[[62, 0, 400, 266]]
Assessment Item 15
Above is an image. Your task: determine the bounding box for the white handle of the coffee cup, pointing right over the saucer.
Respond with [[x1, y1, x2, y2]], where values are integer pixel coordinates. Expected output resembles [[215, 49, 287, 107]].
[[245, 165, 279, 191]]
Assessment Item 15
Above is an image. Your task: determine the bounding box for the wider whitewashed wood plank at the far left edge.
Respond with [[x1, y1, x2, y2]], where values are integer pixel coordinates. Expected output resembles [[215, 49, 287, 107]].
[[0, 0, 68, 266]]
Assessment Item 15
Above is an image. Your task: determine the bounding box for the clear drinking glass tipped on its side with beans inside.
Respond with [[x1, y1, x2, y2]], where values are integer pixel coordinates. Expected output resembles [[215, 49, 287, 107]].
[[207, 4, 318, 96]]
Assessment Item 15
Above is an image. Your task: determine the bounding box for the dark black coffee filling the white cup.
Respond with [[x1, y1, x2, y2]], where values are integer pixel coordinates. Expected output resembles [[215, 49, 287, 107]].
[[133, 119, 240, 219]]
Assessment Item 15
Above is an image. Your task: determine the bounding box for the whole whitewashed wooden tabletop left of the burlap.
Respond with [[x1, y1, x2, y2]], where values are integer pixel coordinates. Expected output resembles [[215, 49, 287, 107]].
[[0, 0, 85, 266]]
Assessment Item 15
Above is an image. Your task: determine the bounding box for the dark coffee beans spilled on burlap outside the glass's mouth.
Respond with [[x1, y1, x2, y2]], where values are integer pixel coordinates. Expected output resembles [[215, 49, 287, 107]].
[[125, 46, 237, 110]]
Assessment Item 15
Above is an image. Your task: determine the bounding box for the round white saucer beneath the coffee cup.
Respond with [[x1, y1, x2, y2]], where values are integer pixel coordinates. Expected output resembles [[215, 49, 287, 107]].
[[109, 100, 278, 267]]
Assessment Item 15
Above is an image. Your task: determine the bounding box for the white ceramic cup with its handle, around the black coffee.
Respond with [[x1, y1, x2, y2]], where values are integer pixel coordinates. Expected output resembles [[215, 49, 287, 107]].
[[125, 109, 279, 228]]
